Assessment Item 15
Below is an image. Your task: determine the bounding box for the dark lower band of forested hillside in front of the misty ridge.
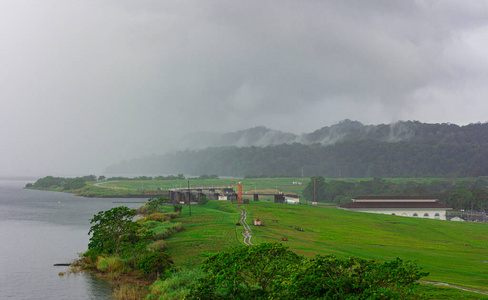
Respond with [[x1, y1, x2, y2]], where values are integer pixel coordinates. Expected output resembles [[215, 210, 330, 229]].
[[110, 141, 488, 178]]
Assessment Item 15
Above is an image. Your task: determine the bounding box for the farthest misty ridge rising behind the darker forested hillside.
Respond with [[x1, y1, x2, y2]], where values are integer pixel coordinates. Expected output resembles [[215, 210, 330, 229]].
[[175, 119, 486, 149]]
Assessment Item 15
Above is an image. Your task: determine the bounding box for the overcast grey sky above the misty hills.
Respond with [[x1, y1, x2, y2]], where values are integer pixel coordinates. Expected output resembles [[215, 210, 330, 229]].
[[0, 0, 488, 176]]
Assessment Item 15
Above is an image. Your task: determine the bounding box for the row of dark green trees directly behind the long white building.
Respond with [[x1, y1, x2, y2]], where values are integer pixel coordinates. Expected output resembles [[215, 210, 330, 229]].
[[303, 176, 488, 212]]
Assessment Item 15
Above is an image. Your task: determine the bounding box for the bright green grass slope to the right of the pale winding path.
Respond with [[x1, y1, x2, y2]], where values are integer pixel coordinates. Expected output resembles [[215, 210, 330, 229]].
[[245, 203, 488, 290]]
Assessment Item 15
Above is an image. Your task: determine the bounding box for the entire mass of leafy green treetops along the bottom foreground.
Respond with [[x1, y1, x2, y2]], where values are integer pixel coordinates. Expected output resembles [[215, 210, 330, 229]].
[[187, 243, 428, 299]]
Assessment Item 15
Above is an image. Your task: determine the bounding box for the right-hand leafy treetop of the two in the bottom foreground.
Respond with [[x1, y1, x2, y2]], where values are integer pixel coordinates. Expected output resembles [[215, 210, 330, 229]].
[[285, 256, 428, 299]]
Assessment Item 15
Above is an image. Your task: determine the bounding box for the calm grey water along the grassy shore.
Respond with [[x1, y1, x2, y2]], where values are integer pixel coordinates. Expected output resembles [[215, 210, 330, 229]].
[[0, 179, 144, 299]]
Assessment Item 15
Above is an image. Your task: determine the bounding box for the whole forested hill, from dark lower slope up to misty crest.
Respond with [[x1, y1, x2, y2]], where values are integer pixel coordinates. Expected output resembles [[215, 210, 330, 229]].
[[106, 120, 488, 177]]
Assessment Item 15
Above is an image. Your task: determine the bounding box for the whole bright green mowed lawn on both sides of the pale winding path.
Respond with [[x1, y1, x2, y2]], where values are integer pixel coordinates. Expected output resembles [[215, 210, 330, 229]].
[[167, 201, 488, 291]]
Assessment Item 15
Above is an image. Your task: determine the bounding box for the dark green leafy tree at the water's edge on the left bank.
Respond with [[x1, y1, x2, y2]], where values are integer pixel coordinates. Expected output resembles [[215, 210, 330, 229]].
[[88, 206, 149, 255]]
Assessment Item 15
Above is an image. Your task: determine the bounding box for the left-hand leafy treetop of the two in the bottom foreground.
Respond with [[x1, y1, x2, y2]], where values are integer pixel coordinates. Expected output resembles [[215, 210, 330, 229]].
[[187, 243, 301, 299]]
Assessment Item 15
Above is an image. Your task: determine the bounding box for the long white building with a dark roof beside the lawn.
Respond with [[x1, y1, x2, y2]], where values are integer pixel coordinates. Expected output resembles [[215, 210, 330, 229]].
[[339, 196, 452, 220]]
